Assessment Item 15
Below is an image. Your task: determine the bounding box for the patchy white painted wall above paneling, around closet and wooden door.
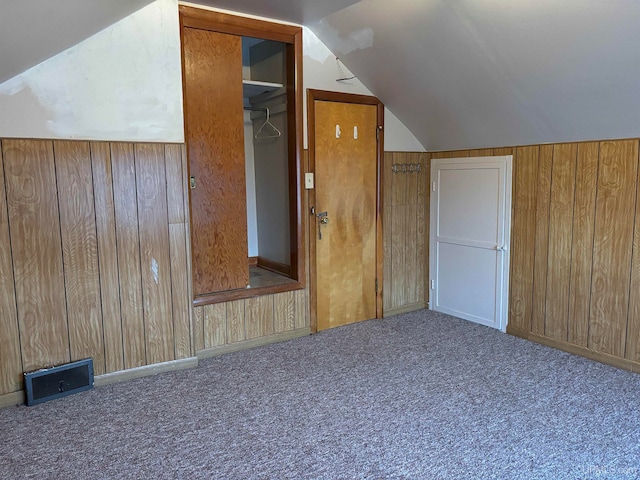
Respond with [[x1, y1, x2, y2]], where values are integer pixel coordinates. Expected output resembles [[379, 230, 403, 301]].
[[0, 0, 424, 151]]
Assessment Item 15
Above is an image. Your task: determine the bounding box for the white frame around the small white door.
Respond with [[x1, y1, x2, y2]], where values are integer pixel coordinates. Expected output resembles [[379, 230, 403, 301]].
[[427, 155, 513, 332]]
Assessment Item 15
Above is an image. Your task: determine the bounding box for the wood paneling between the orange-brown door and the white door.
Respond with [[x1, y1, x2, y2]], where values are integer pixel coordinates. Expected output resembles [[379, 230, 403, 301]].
[[383, 152, 430, 316]]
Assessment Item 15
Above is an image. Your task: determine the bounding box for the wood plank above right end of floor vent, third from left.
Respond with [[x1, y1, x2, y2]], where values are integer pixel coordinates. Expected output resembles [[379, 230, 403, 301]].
[[53, 141, 106, 375]]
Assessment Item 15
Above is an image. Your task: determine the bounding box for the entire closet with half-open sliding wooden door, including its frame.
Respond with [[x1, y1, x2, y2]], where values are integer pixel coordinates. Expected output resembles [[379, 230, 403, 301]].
[[180, 5, 305, 306]]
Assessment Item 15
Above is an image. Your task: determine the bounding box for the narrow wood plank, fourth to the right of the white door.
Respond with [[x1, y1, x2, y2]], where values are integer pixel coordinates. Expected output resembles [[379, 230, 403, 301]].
[[567, 142, 600, 347]]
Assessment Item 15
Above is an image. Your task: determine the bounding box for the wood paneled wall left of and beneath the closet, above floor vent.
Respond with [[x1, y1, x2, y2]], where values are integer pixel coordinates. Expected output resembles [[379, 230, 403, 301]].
[[0, 139, 309, 395]]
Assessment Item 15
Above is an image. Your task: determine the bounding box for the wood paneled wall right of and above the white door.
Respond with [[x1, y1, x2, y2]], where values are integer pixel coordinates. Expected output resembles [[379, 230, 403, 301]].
[[431, 139, 640, 371]]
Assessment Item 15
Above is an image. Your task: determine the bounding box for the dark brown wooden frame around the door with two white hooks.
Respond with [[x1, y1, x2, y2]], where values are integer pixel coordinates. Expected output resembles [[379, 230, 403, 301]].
[[305, 89, 384, 333]]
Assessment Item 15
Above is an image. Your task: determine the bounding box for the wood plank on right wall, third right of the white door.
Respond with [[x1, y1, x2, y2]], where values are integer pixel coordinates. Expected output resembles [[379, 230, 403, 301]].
[[544, 143, 578, 341]]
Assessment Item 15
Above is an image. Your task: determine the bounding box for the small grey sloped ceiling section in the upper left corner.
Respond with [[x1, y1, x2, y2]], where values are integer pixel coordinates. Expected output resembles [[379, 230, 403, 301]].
[[0, 0, 153, 83]]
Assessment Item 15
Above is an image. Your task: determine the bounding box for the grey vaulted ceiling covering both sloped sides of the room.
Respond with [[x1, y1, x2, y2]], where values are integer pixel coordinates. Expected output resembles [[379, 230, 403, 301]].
[[0, 0, 640, 150]]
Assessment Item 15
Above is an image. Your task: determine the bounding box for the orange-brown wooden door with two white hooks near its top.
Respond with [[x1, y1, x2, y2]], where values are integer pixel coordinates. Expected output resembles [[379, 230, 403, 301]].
[[312, 101, 378, 330]]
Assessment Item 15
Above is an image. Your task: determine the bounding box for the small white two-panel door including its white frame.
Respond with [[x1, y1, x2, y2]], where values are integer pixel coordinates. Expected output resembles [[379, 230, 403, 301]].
[[429, 155, 512, 331]]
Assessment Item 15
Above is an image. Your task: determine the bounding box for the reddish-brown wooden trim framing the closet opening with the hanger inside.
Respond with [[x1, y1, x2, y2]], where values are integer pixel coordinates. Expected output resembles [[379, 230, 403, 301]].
[[178, 5, 306, 306]]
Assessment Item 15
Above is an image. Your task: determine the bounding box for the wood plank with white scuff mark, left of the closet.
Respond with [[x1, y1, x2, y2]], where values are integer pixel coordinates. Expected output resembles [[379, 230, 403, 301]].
[[135, 144, 175, 363]]
